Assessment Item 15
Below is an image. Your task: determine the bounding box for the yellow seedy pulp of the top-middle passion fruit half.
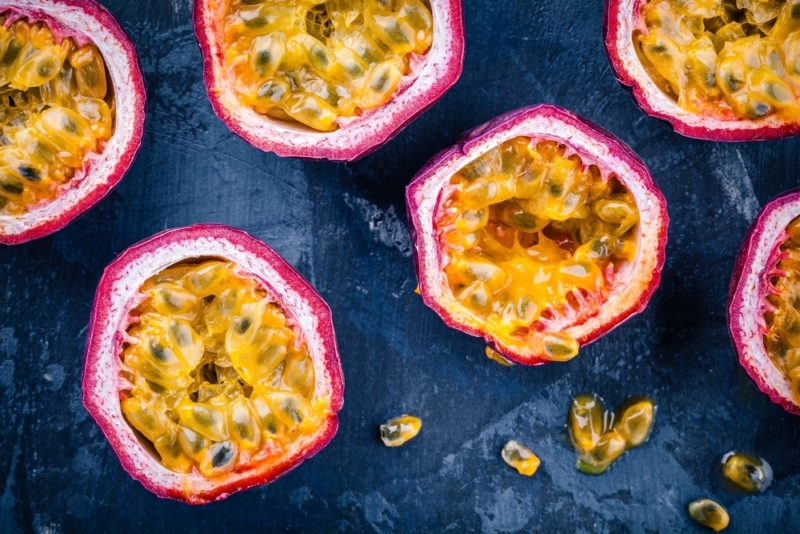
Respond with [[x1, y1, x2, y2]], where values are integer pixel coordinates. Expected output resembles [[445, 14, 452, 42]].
[[223, 0, 433, 132]]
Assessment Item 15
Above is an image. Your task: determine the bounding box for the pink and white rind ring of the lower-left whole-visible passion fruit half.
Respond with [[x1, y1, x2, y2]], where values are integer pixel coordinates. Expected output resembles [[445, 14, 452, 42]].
[[83, 225, 344, 504]]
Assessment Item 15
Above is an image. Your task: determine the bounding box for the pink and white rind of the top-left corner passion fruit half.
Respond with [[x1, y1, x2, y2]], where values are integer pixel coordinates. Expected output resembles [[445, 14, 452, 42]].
[[0, 0, 146, 245]]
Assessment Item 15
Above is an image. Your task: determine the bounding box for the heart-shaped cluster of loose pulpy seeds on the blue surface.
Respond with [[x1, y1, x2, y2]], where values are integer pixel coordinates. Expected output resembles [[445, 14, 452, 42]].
[[567, 393, 655, 475]]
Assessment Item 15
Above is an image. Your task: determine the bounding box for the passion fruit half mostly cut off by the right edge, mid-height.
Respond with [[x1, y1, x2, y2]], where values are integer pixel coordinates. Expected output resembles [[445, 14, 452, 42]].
[[728, 191, 800, 414]]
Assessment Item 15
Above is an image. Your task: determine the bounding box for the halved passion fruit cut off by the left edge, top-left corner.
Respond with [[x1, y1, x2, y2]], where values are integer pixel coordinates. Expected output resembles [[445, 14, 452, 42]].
[[0, 0, 145, 244]]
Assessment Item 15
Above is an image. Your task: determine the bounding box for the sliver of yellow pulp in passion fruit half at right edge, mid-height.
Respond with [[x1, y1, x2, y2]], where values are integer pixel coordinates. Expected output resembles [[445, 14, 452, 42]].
[[764, 217, 800, 401]]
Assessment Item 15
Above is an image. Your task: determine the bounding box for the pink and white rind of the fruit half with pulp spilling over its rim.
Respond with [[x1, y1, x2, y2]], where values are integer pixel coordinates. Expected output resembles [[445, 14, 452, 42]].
[[406, 105, 669, 365]]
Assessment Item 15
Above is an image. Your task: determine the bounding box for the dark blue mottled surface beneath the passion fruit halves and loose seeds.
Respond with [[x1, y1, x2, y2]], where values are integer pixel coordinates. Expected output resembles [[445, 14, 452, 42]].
[[0, 0, 800, 532]]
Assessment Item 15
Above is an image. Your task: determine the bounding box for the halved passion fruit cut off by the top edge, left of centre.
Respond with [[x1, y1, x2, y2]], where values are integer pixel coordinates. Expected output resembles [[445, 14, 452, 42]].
[[194, 0, 464, 161]]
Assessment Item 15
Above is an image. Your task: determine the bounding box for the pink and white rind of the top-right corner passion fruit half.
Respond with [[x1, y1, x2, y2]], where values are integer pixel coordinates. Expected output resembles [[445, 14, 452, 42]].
[[603, 0, 800, 141]]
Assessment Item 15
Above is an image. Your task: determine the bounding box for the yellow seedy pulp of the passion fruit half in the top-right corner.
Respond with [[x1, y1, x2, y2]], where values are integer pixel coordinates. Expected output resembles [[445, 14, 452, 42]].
[[634, 0, 800, 122]]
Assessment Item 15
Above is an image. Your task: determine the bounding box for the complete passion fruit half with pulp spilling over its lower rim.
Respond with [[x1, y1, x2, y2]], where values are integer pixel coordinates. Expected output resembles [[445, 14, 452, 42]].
[[406, 106, 668, 365]]
